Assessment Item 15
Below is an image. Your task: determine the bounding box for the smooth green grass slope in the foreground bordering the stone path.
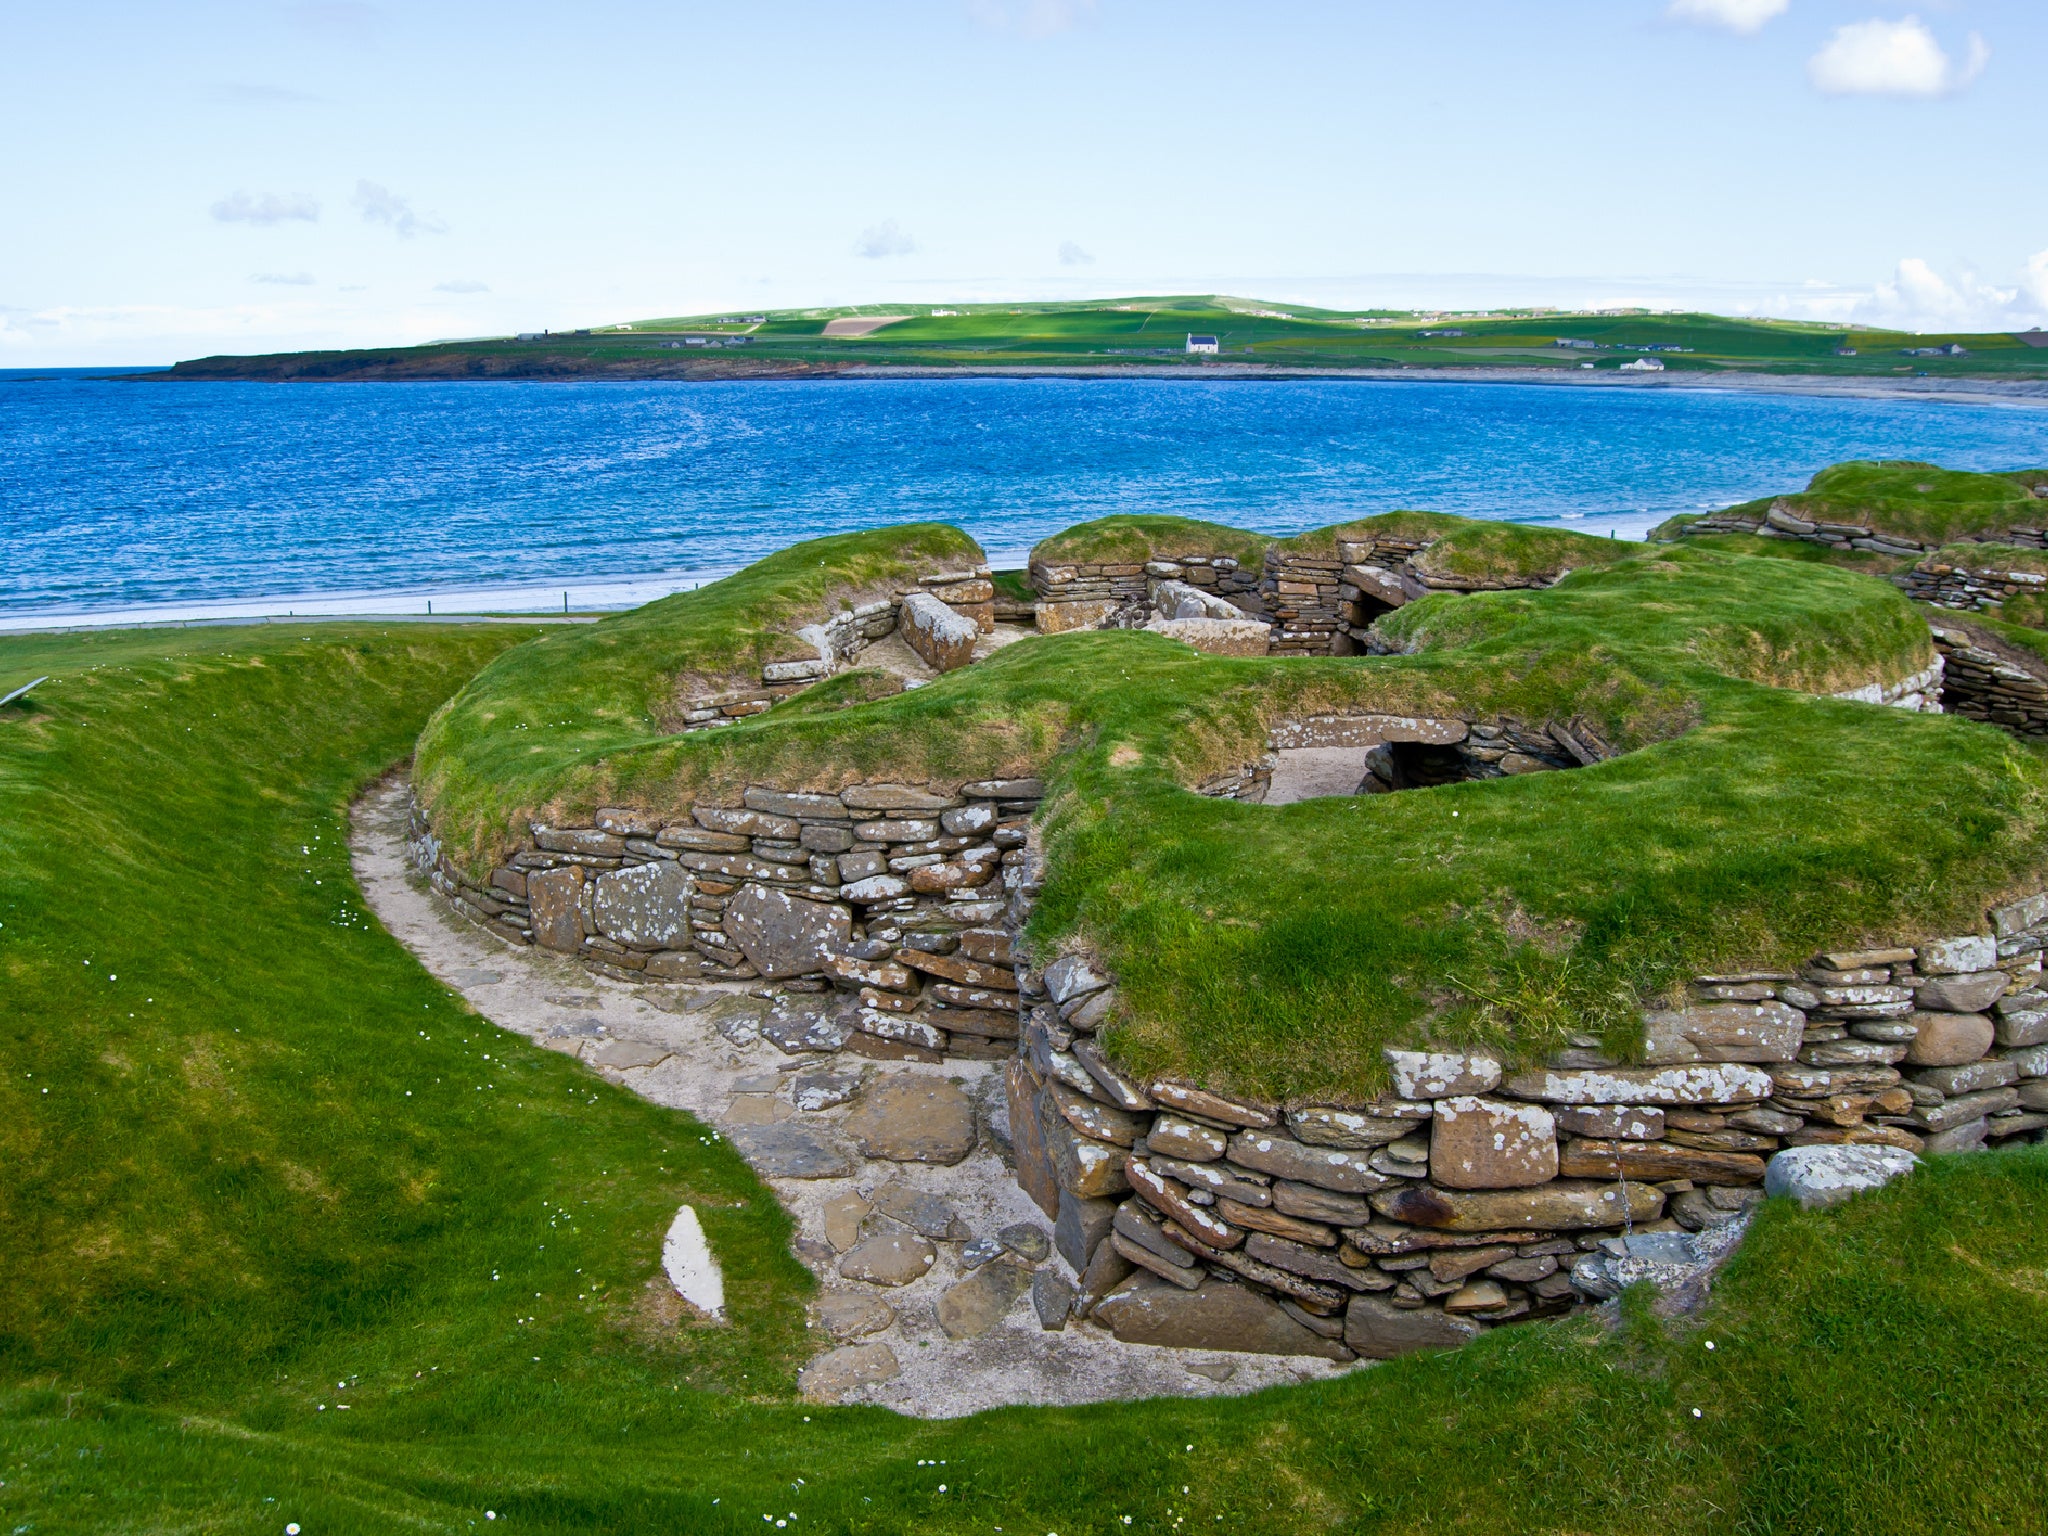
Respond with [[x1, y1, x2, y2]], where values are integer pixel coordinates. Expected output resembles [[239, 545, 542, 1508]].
[[0, 618, 2048, 1536]]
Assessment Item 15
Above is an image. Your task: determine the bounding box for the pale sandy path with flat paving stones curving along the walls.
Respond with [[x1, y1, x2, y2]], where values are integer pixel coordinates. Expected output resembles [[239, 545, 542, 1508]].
[[352, 774, 1350, 1419]]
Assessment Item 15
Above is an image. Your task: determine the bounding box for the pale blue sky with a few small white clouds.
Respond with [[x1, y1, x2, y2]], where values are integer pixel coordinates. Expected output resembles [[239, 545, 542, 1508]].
[[0, 0, 2048, 367]]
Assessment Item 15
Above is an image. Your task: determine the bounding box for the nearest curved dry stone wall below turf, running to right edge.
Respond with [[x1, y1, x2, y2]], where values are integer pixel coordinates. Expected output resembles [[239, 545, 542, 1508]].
[[1006, 893, 2048, 1358]]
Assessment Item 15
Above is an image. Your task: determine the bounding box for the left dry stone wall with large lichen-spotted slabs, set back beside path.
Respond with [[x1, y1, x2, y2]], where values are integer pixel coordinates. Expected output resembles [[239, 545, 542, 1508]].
[[412, 778, 1044, 1059]]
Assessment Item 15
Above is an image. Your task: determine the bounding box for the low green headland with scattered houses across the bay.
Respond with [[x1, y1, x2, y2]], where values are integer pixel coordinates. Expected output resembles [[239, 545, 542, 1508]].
[[162, 297, 2048, 379]]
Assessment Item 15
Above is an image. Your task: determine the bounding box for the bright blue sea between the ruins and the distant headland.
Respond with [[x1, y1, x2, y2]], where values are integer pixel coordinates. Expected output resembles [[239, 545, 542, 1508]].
[[0, 373, 2048, 629]]
